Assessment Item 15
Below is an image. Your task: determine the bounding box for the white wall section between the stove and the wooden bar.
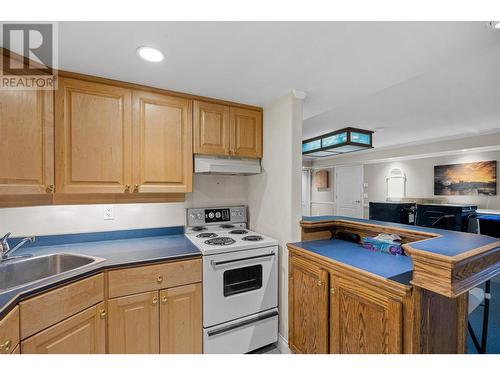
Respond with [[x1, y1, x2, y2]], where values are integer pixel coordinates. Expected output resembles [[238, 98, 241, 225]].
[[248, 94, 302, 346]]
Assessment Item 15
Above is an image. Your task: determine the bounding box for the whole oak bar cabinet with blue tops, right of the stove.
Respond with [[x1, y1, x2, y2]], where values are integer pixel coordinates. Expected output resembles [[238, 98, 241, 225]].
[[287, 216, 500, 354]]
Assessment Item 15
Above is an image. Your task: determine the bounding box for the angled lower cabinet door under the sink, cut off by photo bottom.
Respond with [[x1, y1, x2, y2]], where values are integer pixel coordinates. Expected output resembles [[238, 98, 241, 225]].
[[21, 302, 106, 354]]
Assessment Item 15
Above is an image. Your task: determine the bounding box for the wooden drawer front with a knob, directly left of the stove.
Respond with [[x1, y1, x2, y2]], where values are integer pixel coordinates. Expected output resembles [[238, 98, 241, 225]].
[[108, 259, 202, 298]]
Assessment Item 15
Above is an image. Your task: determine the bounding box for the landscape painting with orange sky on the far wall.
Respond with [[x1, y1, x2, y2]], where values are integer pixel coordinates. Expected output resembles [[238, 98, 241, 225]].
[[434, 160, 497, 195]]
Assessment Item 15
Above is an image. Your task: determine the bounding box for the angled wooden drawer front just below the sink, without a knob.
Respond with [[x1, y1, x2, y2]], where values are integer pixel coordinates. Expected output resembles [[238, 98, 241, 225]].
[[19, 274, 104, 339]]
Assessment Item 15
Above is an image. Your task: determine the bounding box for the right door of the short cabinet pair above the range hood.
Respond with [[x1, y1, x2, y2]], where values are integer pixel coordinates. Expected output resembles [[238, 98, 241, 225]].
[[230, 107, 262, 158]]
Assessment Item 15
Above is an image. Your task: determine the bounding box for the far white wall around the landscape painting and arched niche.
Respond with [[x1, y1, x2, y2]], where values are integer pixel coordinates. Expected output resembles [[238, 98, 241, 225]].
[[364, 151, 500, 209]]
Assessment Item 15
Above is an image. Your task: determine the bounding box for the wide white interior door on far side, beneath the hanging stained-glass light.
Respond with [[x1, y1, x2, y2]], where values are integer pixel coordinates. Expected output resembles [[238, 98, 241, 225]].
[[335, 165, 363, 218]]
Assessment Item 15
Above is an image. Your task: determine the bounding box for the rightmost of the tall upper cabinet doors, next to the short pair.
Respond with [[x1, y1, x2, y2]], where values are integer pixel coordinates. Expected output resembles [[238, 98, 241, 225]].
[[133, 91, 193, 193]]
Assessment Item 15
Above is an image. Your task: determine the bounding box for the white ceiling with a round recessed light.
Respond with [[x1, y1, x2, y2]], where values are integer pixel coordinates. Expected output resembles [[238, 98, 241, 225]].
[[59, 22, 500, 147]]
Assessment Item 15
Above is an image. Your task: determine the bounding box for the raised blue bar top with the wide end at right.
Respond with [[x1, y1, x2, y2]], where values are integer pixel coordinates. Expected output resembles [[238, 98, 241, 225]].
[[302, 216, 500, 257]]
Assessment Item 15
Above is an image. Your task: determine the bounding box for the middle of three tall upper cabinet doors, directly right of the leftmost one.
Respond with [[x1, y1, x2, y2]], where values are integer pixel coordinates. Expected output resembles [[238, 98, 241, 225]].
[[55, 78, 132, 193]]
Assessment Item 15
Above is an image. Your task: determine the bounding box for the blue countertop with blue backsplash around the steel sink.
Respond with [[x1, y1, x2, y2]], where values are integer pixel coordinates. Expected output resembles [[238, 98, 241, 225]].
[[0, 227, 201, 318]]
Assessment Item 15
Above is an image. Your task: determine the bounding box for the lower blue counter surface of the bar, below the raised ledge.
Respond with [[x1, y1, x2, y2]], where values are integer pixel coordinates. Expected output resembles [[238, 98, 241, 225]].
[[292, 239, 413, 284]]
